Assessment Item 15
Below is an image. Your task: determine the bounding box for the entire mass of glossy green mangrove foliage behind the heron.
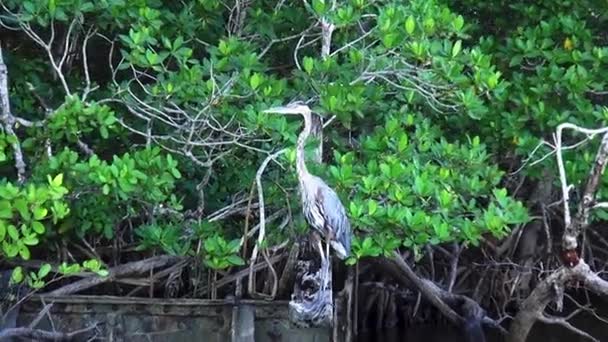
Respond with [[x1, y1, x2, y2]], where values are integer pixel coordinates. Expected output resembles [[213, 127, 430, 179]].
[[0, 0, 576, 269]]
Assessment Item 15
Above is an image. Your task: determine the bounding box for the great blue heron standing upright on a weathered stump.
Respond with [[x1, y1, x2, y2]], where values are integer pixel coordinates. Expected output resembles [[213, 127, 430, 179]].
[[264, 102, 351, 261]]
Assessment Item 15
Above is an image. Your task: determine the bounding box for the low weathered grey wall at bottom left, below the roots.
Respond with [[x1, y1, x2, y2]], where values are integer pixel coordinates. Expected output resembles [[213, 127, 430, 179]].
[[17, 296, 331, 342]]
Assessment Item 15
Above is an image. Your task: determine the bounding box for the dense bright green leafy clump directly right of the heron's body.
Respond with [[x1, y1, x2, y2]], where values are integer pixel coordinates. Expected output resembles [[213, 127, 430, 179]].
[[330, 112, 528, 257]]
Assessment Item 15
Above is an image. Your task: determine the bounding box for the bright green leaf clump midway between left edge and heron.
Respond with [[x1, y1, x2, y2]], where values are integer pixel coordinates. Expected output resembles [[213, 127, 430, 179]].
[[33, 148, 181, 239]]
